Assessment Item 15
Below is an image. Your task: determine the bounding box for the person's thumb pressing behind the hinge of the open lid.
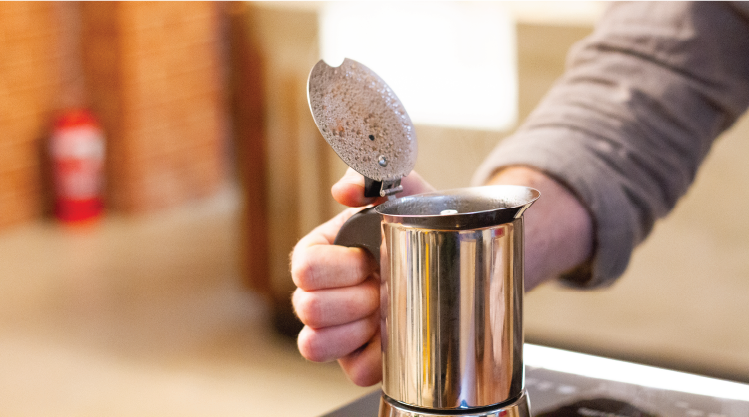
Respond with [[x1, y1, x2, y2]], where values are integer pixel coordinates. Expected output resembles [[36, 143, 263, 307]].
[[330, 168, 434, 207]]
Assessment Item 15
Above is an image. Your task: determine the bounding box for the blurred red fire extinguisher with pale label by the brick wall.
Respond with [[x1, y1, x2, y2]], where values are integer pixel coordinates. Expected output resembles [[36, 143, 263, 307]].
[[50, 109, 105, 222]]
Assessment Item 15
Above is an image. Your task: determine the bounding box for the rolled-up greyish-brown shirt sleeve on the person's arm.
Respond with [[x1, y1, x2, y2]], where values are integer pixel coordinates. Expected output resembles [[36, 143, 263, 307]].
[[474, 0, 749, 287]]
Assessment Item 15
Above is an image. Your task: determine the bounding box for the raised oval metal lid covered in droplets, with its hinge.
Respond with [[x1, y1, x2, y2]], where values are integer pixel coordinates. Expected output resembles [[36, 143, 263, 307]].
[[307, 58, 417, 196]]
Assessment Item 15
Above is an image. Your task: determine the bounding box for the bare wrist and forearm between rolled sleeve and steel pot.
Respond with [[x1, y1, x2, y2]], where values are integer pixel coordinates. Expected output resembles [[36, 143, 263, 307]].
[[488, 167, 594, 290]]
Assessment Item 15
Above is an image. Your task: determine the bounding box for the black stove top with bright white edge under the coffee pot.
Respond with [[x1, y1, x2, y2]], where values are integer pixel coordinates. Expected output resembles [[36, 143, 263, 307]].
[[323, 344, 749, 417]]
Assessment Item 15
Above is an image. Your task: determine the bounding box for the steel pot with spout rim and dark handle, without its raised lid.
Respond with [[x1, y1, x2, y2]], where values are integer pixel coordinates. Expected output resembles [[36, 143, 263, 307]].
[[335, 186, 539, 415]]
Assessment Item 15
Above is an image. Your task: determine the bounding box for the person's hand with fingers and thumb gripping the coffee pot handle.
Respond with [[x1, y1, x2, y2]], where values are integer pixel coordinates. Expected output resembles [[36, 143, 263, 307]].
[[291, 169, 433, 386]]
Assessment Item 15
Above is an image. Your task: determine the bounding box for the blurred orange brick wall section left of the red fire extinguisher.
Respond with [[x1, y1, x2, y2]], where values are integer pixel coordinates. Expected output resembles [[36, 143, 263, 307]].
[[0, 0, 66, 228]]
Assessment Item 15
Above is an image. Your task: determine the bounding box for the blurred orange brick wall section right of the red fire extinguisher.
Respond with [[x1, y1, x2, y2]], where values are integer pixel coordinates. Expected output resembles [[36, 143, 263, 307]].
[[81, 0, 226, 212]]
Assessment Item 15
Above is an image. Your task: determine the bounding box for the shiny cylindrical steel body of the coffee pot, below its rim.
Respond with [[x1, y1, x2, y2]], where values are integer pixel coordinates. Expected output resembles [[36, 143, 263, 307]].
[[380, 216, 523, 409]]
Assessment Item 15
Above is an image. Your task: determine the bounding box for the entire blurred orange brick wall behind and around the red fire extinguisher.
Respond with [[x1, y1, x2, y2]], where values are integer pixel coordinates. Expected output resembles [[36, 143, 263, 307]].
[[0, 0, 227, 229]]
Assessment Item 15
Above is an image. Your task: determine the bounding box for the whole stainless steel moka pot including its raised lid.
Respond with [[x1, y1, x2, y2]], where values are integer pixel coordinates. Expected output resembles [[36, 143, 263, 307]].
[[308, 59, 539, 417]]
